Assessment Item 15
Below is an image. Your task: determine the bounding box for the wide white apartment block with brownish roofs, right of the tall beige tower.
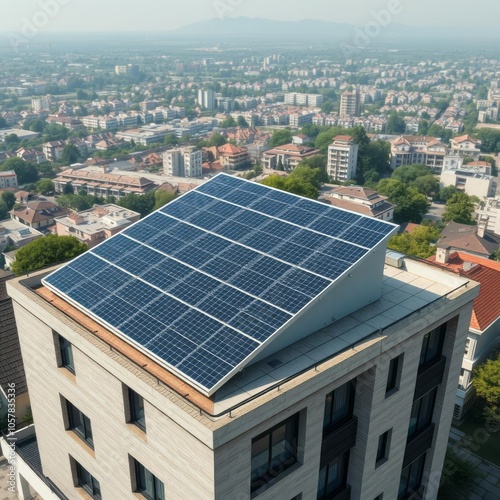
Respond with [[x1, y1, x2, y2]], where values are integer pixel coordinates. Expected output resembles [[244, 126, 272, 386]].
[[391, 135, 448, 172]]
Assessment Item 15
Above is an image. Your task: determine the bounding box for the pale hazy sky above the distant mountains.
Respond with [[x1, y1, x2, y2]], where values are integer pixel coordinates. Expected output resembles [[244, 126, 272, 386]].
[[0, 0, 500, 35]]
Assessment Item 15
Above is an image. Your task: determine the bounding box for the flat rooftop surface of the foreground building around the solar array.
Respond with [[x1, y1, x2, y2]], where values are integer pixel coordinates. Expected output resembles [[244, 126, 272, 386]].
[[29, 258, 471, 416]]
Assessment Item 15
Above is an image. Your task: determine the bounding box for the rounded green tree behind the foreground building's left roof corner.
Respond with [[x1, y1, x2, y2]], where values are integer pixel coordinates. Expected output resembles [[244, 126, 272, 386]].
[[12, 234, 88, 276]]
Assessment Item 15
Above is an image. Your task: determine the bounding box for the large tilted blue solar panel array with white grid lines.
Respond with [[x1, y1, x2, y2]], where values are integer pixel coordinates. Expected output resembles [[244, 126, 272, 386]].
[[44, 174, 395, 395]]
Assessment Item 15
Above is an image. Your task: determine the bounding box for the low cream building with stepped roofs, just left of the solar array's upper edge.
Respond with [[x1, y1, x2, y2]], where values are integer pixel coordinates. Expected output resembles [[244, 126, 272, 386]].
[[55, 203, 141, 248]]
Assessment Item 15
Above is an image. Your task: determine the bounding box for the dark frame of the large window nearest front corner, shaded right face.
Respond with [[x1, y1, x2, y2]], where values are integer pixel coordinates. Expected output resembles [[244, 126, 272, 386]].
[[250, 413, 300, 496]]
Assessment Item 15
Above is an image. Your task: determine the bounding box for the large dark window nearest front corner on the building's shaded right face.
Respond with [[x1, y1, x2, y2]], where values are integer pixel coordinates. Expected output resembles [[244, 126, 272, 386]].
[[251, 413, 299, 493]]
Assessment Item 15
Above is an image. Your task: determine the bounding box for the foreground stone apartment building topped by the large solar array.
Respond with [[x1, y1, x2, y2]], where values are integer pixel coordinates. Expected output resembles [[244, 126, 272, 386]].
[[4, 175, 478, 500]]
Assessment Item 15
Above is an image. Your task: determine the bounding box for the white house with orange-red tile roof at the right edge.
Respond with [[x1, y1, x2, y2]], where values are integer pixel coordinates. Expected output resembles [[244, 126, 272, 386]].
[[429, 247, 500, 419]]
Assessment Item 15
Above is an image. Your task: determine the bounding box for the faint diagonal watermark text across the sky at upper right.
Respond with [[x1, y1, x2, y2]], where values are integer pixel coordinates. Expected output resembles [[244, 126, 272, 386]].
[[340, 0, 413, 57]]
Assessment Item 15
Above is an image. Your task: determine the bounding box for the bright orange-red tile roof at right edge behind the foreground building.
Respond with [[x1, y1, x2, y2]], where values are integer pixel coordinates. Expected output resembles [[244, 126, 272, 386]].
[[428, 252, 500, 331]]
